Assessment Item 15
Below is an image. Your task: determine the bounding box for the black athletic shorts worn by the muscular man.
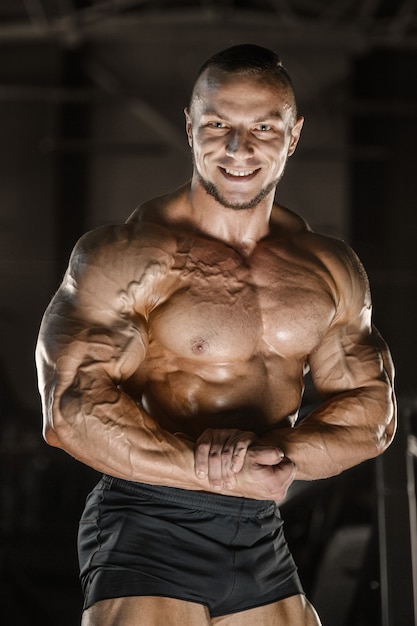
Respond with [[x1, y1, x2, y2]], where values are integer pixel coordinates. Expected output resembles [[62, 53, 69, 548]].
[[78, 475, 303, 617]]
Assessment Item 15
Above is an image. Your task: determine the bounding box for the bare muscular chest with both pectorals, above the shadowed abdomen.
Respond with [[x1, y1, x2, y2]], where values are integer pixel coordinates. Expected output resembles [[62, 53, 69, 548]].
[[149, 238, 335, 363]]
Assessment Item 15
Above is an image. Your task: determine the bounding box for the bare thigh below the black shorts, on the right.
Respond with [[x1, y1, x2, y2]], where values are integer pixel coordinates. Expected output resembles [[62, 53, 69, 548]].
[[211, 595, 321, 626]]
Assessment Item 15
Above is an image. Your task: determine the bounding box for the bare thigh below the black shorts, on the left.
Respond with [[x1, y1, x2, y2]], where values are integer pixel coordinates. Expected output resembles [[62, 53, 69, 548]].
[[81, 596, 211, 626]]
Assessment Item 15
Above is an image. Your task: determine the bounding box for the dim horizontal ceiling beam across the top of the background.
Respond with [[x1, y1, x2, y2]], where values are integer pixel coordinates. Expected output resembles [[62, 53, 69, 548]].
[[0, 0, 417, 48]]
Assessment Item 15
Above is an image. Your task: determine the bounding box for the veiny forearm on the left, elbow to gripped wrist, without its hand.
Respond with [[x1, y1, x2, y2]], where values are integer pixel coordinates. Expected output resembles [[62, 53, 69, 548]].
[[45, 373, 204, 489]]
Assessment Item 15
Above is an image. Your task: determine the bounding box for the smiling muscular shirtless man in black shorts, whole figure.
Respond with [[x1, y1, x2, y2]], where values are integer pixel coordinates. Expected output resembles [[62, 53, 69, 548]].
[[37, 45, 395, 626]]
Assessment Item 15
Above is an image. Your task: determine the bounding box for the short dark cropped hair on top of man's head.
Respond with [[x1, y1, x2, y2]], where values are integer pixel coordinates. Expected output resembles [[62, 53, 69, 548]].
[[196, 43, 297, 115]]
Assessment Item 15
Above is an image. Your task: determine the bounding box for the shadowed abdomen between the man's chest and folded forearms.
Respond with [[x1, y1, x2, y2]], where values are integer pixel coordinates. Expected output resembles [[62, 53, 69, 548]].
[[125, 357, 303, 438]]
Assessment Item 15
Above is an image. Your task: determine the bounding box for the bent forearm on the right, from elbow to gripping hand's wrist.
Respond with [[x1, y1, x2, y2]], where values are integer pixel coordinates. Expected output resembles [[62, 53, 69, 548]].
[[260, 387, 395, 480]]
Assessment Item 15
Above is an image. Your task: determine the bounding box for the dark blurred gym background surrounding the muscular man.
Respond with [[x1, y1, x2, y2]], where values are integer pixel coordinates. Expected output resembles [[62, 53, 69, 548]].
[[0, 0, 417, 626]]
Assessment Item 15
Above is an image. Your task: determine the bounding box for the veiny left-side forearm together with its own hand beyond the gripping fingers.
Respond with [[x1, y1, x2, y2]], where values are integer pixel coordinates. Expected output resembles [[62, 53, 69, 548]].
[[47, 381, 293, 501]]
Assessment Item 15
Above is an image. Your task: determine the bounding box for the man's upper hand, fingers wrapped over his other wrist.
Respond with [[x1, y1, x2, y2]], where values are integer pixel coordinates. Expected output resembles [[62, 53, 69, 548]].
[[194, 428, 257, 491]]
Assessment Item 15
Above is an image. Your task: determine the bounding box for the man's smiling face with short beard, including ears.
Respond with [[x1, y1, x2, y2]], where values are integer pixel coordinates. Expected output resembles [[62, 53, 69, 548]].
[[185, 69, 303, 210]]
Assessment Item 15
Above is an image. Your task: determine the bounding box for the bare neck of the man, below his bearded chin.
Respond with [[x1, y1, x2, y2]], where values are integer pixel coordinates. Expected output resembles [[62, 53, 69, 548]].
[[189, 177, 274, 253]]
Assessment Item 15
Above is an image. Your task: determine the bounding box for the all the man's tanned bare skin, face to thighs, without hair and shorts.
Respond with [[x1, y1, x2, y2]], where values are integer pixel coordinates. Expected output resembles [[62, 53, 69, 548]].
[[37, 68, 395, 626]]
